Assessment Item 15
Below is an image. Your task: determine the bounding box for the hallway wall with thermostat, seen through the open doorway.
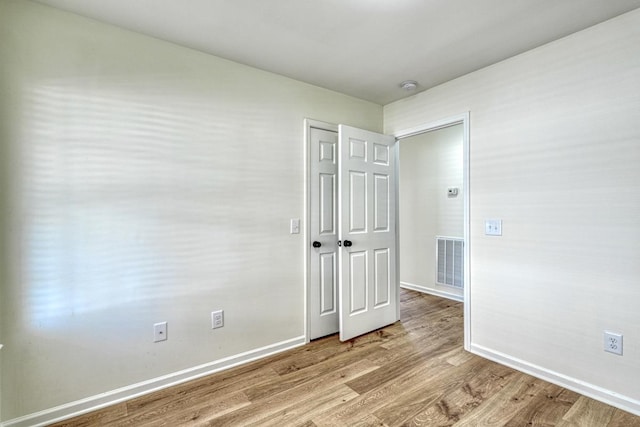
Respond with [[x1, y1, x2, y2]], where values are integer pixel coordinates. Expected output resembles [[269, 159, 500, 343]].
[[399, 124, 464, 299]]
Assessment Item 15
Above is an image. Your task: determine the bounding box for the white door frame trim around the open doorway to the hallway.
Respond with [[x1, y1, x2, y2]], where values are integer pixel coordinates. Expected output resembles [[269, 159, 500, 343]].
[[393, 111, 471, 351]]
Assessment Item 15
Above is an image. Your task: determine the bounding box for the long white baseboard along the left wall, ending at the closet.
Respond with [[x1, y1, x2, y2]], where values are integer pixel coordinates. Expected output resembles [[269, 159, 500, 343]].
[[0, 336, 307, 427]]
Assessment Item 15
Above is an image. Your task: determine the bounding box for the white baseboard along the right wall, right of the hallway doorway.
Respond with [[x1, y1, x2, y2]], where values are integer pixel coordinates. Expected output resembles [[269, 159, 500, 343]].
[[469, 343, 640, 416]]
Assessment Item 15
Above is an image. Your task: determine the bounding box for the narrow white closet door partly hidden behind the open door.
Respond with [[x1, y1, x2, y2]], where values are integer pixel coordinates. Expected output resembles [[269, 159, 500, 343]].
[[309, 128, 339, 339]]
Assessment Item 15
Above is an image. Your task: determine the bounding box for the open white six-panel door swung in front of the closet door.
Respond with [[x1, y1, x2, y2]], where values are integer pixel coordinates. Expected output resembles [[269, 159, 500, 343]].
[[338, 125, 399, 341]]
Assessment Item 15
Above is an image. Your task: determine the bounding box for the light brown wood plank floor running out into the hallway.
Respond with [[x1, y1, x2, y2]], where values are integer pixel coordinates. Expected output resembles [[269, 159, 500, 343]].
[[55, 290, 640, 427]]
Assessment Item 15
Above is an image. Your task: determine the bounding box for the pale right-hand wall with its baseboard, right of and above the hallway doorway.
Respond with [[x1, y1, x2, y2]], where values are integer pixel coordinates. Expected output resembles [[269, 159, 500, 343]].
[[384, 10, 640, 413]]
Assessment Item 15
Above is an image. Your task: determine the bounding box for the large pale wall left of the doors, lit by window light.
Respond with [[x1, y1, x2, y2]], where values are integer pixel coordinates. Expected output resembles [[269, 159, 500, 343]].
[[0, 0, 382, 420]]
